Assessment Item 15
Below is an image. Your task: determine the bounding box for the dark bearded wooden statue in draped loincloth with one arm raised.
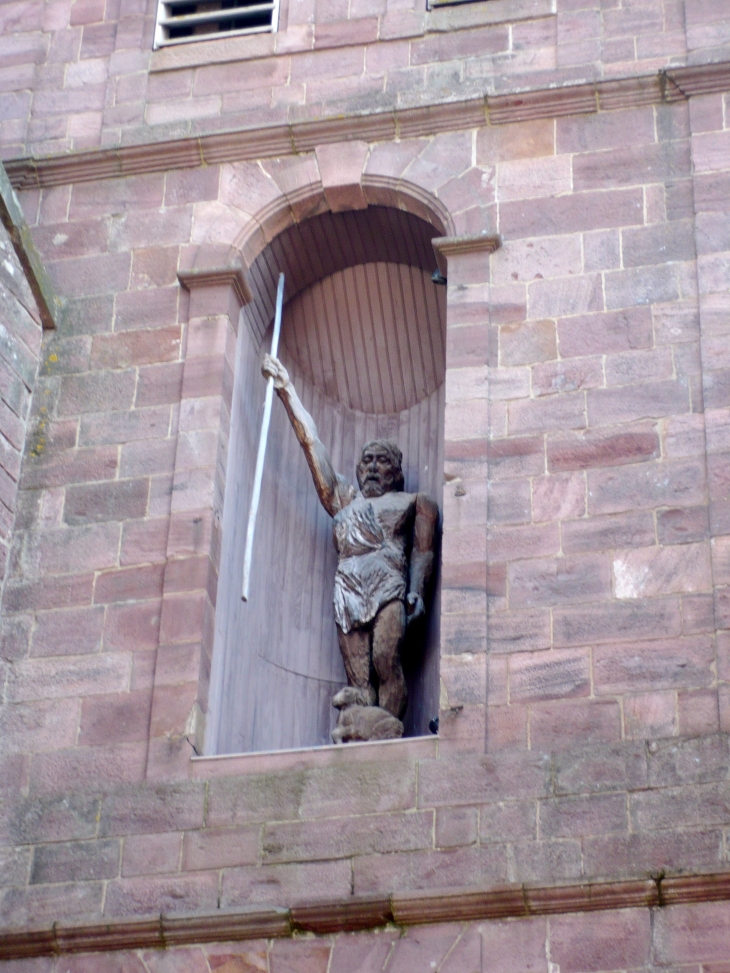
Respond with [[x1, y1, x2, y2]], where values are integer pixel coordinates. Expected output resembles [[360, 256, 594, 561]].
[[261, 355, 438, 743]]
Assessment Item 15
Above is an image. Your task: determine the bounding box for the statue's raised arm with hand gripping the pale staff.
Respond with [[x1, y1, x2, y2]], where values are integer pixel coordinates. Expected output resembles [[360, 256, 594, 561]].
[[261, 355, 354, 517]]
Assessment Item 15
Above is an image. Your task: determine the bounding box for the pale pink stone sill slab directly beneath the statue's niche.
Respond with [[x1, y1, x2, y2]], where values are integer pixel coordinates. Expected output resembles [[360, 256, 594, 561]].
[[190, 736, 438, 780]]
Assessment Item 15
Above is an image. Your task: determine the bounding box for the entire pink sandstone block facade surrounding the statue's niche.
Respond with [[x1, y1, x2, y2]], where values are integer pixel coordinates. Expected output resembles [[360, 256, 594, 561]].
[[0, 0, 730, 973]]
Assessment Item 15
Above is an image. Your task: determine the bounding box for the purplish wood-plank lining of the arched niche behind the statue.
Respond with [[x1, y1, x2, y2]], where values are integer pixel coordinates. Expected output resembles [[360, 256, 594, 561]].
[[206, 206, 445, 754]]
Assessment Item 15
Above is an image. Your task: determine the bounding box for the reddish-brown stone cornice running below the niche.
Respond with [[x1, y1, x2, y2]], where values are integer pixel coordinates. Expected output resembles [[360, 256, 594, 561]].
[[0, 872, 730, 960]]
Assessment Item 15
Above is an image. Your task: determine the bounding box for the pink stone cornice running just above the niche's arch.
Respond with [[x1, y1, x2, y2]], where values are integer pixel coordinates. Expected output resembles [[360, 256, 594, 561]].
[[5, 62, 730, 189]]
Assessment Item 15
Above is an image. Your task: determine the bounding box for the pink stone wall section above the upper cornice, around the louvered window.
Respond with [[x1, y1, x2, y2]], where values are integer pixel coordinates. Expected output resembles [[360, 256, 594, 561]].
[[0, 0, 730, 158]]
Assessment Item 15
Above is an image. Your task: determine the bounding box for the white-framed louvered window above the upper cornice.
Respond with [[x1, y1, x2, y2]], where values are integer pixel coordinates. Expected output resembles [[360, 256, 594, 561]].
[[155, 0, 279, 47]]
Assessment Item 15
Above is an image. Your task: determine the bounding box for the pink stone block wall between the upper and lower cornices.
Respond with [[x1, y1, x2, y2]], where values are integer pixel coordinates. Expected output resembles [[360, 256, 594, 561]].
[[2, 95, 730, 925]]
